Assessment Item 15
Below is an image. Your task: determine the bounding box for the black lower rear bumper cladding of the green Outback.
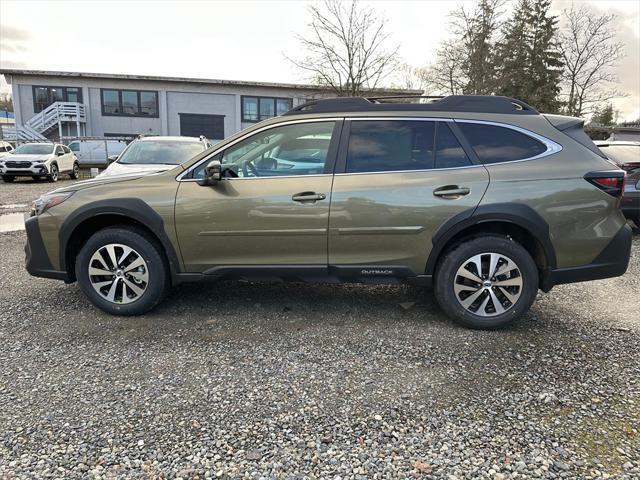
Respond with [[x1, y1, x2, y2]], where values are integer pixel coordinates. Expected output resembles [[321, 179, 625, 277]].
[[540, 225, 632, 292]]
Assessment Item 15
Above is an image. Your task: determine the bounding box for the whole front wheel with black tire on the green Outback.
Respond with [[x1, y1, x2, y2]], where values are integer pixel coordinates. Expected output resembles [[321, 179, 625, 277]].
[[75, 226, 170, 316]]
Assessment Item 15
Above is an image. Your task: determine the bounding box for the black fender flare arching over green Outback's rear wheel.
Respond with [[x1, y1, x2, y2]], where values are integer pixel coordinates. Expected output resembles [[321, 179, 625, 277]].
[[425, 203, 557, 275]]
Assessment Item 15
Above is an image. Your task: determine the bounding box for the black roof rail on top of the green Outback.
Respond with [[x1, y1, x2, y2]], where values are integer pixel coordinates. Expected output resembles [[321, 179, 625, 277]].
[[284, 95, 539, 115]]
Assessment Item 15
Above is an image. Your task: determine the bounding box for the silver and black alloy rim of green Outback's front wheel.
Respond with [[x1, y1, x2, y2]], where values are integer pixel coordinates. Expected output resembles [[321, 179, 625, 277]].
[[88, 243, 149, 304]]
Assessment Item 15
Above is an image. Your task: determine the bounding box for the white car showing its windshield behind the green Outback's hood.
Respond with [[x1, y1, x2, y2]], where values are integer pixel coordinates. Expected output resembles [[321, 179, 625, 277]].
[[98, 136, 211, 177]]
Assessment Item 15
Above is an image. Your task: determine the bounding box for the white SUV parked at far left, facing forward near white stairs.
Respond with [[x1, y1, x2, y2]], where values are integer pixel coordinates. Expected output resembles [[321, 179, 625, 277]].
[[0, 143, 80, 182]]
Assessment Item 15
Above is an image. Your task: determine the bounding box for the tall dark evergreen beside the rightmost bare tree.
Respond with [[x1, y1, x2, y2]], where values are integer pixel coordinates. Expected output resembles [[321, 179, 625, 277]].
[[497, 0, 563, 113]]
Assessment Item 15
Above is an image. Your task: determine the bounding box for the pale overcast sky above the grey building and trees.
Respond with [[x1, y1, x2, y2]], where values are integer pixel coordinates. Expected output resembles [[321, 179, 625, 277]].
[[0, 0, 640, 119]]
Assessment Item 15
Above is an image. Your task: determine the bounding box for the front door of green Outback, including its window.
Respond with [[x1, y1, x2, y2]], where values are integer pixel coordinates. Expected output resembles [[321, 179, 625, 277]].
[[175, 120, 341, 274]]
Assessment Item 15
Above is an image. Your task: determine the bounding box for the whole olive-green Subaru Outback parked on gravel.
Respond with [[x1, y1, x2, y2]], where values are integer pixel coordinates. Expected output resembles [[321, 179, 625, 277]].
[[26, 96, 631, 328]]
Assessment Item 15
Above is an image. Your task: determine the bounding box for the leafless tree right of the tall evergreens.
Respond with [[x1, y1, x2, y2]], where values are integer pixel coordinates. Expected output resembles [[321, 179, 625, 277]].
[[559, 6, 624, 117]]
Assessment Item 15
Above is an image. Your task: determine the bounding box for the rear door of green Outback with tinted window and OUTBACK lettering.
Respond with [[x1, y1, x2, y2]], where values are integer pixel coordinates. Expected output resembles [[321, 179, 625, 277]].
[[329, 118, 489, 278]]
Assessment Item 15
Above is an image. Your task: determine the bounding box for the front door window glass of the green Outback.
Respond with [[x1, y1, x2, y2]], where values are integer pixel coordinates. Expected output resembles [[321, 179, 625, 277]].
[[193, 122, 335, 178]]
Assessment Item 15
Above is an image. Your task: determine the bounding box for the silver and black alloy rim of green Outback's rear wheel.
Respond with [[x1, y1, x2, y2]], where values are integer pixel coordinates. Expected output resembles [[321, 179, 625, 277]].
[[453, 252, 522, 317]]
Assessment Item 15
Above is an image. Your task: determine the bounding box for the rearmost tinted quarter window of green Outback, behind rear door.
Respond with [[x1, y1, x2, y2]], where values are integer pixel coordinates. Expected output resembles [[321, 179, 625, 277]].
[[457, 122, 547, 163]]
